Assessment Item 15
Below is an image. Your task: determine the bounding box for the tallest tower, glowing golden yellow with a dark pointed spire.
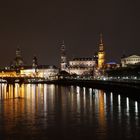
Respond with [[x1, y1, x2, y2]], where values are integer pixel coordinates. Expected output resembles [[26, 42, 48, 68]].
[[98, 34, 105, 69]]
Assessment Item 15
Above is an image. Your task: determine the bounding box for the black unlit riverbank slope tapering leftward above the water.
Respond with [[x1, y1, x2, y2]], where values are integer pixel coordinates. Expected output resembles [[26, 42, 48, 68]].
[[26, 79, 140, 95]]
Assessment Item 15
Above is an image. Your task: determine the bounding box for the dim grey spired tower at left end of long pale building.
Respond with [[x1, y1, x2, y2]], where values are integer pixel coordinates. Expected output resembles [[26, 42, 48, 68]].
[[60, 41, 67, 71]]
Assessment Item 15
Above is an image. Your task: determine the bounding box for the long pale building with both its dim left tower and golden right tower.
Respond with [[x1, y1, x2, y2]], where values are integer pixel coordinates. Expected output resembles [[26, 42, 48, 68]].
[[60, 34, 105, 75]]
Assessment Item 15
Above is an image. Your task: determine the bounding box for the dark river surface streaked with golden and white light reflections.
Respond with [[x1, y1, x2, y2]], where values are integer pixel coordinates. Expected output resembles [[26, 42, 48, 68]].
[[0, 84, 140, 140]]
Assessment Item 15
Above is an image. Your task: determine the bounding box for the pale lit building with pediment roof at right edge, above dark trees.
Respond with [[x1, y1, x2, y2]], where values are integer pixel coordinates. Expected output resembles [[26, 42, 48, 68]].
[[121, 55, 140, 67]]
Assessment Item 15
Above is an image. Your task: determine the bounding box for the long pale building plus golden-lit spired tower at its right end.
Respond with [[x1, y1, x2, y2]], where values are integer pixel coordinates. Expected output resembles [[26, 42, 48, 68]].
[[68, 34, 105, 76]]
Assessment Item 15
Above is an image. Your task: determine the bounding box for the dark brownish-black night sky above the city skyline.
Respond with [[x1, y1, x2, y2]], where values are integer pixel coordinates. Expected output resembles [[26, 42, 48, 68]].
[[0, 0, 140, 66]]
